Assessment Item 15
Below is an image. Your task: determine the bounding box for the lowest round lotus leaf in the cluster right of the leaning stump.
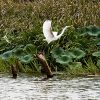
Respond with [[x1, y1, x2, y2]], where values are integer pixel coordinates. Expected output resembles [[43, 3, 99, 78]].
[[56, 55, 72, 64]]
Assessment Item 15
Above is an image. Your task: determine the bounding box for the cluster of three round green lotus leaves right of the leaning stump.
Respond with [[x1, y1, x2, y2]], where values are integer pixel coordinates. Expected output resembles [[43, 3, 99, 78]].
[[51, 48, 85, 64]]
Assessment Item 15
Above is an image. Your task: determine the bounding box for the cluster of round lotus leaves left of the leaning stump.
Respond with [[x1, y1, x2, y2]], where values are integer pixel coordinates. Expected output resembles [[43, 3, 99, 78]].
[[0, 44, 34, 64]]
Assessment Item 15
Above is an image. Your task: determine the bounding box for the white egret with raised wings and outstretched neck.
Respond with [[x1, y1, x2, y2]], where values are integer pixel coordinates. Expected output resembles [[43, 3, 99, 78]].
[[43, 20, 71, 44]]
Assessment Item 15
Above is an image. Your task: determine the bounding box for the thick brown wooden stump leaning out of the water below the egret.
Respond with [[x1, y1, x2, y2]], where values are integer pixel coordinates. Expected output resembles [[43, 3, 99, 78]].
[[37, 53, 53, 78]]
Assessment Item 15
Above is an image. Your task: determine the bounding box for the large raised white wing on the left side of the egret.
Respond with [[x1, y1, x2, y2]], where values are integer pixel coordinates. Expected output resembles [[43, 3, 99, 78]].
[[43, 20, 54, 39]]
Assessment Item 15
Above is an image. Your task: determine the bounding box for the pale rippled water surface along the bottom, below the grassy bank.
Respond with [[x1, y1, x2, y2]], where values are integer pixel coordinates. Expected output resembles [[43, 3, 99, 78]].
[[0, 76, 100, 100]]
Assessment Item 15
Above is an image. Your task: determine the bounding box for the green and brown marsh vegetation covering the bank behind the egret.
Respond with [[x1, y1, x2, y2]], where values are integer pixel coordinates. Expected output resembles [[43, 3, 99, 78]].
[[0, 0, 100, 76]]
